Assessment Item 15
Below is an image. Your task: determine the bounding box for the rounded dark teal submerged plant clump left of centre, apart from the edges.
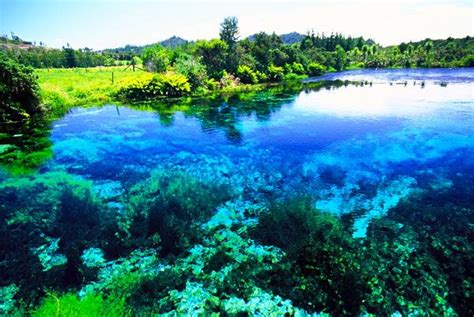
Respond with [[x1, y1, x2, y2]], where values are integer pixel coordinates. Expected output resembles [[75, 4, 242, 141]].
[[120, 169, 231, 254]]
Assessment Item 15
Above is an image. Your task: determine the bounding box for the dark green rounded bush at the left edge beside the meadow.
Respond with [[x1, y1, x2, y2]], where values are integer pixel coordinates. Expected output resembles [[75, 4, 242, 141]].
[[0, 53, 41, 121]]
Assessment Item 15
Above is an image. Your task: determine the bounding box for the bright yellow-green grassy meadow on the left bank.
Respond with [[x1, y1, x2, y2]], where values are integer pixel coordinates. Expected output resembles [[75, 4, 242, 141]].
[[35, 66, 152, 114]]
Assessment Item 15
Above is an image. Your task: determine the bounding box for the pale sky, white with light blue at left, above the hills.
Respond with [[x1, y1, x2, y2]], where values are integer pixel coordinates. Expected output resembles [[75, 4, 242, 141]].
[[0, 0, 474, 49]]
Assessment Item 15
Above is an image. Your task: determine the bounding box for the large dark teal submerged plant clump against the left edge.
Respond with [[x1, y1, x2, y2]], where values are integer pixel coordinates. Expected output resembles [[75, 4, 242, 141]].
[[0, 172, 118, 302]]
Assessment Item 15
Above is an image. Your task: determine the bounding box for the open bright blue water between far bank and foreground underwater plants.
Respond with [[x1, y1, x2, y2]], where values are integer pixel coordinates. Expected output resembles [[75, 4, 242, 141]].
[[2, 69, 474, 314]]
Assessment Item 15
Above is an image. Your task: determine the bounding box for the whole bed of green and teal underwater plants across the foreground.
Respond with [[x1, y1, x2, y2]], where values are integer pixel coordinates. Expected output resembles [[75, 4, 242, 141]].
[[0, 161, 474, 316]]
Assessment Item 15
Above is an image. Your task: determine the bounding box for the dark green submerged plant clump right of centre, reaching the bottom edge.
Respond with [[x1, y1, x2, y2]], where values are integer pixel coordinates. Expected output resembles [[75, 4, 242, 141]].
[[251, 198, 364, 314]]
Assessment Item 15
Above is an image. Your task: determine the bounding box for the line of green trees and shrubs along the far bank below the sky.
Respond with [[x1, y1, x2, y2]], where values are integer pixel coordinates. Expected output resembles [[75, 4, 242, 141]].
[[0, 17, 474, 77]]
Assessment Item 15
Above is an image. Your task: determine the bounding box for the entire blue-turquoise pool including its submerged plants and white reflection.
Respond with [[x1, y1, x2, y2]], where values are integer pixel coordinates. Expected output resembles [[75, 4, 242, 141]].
[[0, 69, 474, 315]]
